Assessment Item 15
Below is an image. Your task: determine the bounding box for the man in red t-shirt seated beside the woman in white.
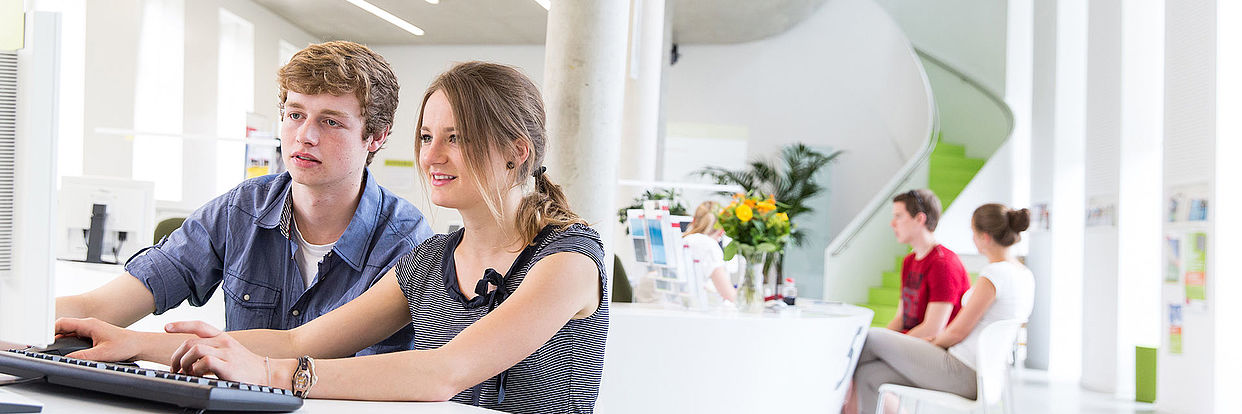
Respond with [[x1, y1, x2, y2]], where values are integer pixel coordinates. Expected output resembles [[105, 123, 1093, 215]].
[[888, 189, 970, 338]]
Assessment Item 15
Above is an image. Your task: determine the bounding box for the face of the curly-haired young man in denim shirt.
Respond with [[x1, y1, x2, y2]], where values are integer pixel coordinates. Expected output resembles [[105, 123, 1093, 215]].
[[281, 91, 386, 188]]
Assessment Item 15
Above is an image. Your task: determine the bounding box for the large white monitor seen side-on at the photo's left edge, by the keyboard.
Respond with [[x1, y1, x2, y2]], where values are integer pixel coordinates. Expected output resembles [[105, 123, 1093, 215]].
[[0, 12, 61, 345]]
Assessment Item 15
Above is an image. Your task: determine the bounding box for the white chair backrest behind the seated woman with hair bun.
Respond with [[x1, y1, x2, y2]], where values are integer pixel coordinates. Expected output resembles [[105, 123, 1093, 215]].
[[975, 320, 1026, 407]]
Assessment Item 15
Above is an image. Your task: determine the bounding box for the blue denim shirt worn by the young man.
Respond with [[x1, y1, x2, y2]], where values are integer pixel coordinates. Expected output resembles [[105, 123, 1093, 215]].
[[125, 170, 432, 356]]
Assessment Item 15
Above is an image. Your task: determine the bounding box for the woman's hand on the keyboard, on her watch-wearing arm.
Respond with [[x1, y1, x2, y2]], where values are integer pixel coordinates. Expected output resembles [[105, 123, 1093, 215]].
[[164, 321, 270, 385]]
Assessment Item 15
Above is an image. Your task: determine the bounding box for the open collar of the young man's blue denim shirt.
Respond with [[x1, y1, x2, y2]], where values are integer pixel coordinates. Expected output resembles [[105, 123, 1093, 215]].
[[255, 169, 384, 271]]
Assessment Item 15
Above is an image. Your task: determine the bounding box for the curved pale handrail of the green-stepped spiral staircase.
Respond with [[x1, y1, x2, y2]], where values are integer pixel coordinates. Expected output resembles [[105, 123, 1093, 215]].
[[827, 45, 1013, 256]]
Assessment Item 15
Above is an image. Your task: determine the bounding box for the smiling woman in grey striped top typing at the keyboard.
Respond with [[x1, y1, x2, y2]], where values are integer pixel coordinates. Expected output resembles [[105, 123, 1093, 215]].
[[56, 62, 609, 413]]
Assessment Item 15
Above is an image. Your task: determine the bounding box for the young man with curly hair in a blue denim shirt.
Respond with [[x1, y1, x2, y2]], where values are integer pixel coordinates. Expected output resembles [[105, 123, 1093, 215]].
[[56, 41, 431, 354]]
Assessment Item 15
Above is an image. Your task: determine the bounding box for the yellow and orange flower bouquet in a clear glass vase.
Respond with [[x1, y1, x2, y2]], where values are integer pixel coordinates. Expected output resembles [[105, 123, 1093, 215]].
[[715, 193, 792, 312]]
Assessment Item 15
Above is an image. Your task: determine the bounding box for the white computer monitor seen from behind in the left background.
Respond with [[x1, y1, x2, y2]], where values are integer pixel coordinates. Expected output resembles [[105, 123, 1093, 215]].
[[56, 177, 155, 264]]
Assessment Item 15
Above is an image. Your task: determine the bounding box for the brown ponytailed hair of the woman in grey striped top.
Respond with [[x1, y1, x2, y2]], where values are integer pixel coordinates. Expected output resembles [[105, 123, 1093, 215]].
[[414, 61, 586, 242]]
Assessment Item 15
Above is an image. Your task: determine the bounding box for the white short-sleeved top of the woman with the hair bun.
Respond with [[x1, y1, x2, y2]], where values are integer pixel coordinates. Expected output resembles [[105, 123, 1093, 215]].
[[949, 261, 1035, 369]]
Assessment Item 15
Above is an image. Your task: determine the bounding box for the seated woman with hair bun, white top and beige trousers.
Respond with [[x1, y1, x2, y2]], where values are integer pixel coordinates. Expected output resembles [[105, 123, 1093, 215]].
[[846, 204, 1035, 413]]
